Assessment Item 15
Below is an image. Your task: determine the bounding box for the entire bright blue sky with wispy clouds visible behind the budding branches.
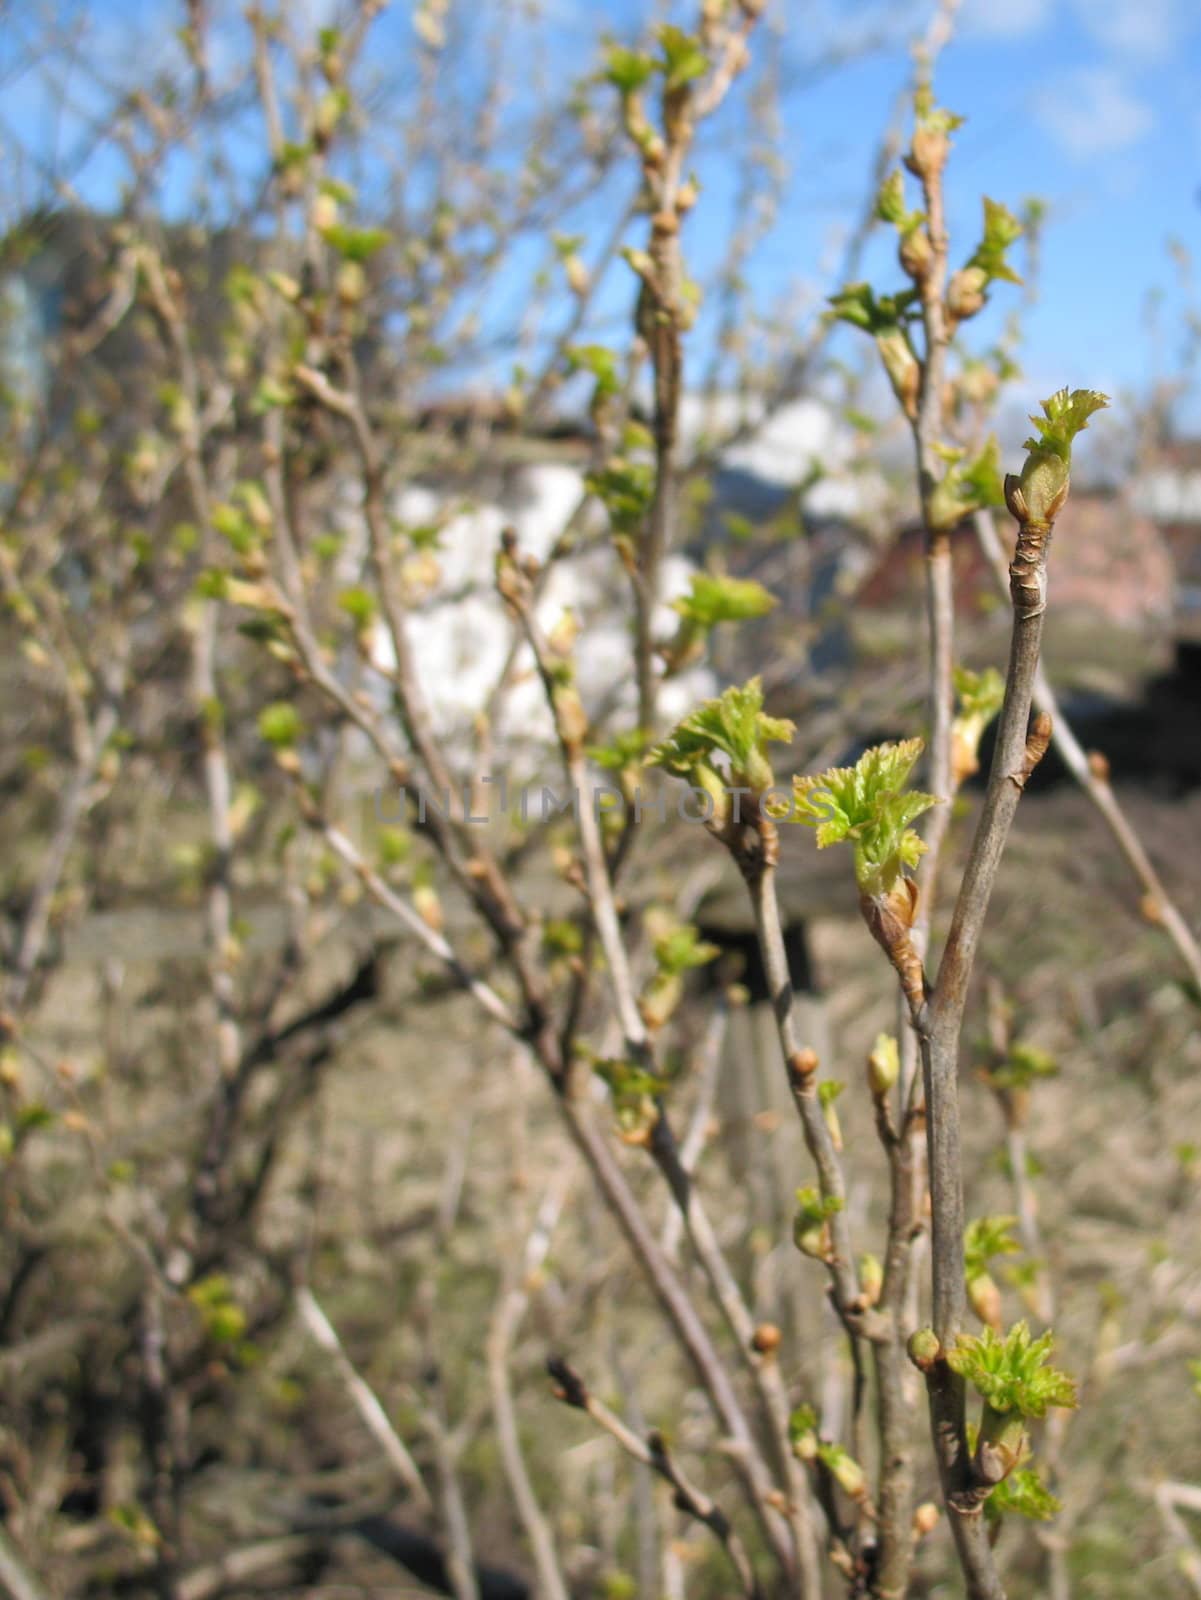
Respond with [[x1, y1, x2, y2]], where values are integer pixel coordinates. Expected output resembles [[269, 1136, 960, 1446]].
[[0, 0, 1201, 448]]
